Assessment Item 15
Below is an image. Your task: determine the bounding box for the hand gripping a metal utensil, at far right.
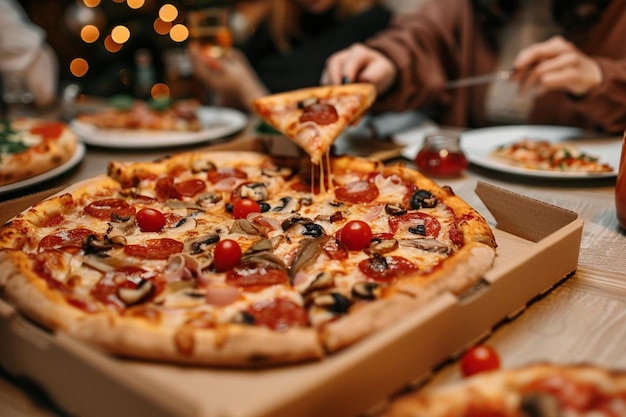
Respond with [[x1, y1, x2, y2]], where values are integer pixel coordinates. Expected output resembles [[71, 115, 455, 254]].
[[513, 36, 602, 96]]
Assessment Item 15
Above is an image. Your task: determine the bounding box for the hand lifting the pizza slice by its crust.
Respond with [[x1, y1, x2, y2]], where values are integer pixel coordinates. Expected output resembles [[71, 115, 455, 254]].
[[321, 43, 398, 94]]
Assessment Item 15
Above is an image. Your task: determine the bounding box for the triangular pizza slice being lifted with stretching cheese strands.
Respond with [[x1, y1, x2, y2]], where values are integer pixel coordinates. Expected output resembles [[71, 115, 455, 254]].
[[252, 83, 376, 164]]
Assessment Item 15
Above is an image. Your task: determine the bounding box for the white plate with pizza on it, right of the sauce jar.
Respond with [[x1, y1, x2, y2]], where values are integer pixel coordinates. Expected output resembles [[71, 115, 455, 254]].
[[461, 125, 622, 178]]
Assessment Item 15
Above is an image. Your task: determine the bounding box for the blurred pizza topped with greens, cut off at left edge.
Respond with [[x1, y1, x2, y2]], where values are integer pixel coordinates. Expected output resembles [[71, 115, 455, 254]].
[[0, 117, 78, 186]]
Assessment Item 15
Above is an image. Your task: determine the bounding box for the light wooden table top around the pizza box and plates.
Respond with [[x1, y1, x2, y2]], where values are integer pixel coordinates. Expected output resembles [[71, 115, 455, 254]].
[[0, 118, 626, 416]]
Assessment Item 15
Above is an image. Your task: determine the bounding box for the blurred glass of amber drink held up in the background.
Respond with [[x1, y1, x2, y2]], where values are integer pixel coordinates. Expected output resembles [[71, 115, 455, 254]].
[[187, 6, 232, 58]]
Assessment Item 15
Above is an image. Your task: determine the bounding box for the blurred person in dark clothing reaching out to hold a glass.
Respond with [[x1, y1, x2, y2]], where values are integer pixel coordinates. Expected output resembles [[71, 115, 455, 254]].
[[188, 0, 391, 110]]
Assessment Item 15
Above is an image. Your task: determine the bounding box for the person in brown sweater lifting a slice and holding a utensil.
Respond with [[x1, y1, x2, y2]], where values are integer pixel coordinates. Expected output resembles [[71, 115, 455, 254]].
[[322, 0, 626, 133]]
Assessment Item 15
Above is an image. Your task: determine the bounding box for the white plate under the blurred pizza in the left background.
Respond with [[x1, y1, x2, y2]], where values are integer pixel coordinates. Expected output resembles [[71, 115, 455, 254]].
[[70, 106, 248, 149]]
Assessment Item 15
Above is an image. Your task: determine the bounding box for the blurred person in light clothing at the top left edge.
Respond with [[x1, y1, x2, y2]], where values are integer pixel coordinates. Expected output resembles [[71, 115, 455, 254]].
[[0, 0, 59, 109]]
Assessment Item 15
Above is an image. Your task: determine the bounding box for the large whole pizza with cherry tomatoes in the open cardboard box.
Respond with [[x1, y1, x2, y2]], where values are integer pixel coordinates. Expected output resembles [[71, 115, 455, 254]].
[[0, 148, 496, 367]]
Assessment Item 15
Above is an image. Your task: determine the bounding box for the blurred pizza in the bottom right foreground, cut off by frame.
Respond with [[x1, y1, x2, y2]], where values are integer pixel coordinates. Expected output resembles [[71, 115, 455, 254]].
[[384, 363, 626, 417]]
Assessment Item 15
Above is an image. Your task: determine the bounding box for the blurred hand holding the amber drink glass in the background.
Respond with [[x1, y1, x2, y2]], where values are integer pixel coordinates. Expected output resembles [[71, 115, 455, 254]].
[[187, 42, 268, 109]]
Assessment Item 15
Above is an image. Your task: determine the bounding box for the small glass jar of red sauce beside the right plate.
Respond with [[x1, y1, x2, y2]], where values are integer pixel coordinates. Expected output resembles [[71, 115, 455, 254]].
[[414, 132, 467, 178]]
